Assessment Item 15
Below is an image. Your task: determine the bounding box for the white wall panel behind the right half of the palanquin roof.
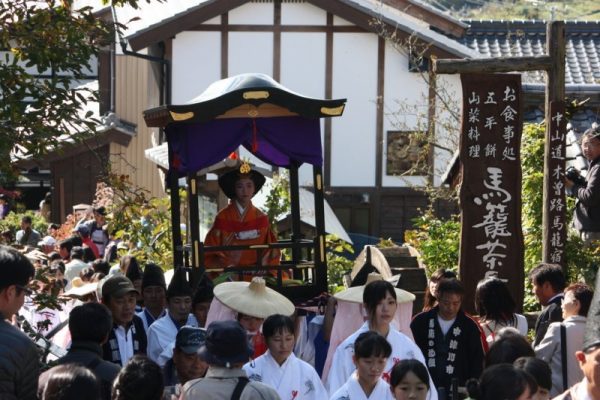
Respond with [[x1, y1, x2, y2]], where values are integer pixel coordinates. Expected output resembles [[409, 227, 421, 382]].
[[280, 32, 326, 186]]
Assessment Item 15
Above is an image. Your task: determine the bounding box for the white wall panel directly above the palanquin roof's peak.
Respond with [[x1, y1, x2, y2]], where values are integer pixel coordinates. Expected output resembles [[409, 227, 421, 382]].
[[228, 32, 273, 76]]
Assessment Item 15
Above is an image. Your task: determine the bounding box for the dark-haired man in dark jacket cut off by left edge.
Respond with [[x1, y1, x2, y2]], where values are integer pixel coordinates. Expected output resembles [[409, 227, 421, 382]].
[[0, 246, 40, 400]]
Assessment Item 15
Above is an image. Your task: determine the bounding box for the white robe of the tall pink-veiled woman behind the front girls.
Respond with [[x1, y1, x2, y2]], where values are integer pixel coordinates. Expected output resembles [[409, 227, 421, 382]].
[[325, 322, 438, 400]]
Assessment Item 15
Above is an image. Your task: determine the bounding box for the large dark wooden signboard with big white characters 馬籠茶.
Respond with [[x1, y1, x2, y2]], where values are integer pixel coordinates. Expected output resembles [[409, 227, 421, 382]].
[[459, 74, 524, 312]]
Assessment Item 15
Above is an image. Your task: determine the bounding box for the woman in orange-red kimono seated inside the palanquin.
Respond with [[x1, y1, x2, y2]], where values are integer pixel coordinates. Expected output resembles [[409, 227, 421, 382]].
[[204, 162, 281, 276]]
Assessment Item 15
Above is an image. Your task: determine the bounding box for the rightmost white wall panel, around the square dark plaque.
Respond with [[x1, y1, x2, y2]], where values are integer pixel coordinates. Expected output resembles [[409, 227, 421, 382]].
[[381, 44, 428, 187]]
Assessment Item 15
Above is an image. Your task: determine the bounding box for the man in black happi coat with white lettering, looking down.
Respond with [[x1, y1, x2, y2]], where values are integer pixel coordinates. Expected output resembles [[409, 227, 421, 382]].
[[410, 279, 487, 393]]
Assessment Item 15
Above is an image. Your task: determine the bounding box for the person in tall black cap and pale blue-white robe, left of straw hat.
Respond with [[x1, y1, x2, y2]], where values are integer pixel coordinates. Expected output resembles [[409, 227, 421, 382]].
[[148, 268, 198, 367]]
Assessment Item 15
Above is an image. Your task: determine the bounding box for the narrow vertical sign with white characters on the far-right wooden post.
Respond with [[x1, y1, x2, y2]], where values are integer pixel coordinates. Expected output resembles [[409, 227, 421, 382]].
[[542, 101, 567, 265]]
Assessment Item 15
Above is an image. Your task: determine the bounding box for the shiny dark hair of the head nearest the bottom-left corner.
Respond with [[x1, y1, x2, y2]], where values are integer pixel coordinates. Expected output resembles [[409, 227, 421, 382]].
[[41, 364, 100, 400]]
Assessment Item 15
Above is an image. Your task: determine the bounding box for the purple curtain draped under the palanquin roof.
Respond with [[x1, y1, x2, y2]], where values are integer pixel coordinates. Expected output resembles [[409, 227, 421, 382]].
[[166, 117, 323, 175]]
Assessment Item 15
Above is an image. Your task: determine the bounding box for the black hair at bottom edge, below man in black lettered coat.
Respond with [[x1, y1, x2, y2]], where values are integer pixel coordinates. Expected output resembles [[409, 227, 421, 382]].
[[465, 364, 537, 400]]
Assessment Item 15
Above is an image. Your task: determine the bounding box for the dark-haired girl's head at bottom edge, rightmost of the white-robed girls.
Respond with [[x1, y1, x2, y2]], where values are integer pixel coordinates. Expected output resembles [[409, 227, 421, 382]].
[[390, 359, 429, 400]]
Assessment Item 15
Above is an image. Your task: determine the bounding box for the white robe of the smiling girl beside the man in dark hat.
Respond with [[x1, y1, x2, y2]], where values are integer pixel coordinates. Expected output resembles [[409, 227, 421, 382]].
[[243, 350, 327, 400]]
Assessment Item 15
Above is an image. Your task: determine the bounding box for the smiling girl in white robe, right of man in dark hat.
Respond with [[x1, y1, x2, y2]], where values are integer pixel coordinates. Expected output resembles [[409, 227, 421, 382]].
[[244, 314, 327, 400]]
